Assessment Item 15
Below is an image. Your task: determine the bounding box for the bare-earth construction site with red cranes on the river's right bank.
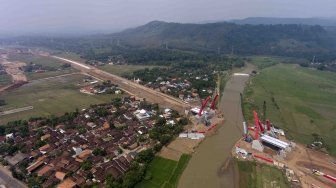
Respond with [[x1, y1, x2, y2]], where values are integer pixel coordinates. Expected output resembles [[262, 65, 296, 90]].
[[232, 111, 336, 188]]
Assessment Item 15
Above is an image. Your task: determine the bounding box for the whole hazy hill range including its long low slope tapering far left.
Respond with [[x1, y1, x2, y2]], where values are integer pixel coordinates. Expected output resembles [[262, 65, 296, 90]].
[[2, 21, 336, 61]]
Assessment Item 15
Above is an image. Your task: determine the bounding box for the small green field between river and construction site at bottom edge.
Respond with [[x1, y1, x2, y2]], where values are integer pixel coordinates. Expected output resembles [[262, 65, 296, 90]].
[[236, 160, 291, 188]]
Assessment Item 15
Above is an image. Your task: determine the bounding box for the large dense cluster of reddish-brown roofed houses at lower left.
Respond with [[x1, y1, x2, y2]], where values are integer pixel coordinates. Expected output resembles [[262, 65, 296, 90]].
[[0, 97, 175, 188]]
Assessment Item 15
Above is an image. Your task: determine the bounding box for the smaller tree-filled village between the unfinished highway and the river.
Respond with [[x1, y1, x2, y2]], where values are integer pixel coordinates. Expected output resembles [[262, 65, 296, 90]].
[[124, 66, 217, 104]]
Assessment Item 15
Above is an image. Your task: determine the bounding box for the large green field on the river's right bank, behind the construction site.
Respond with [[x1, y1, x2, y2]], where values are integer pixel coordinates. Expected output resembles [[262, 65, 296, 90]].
[[243, 64, 336, 155]]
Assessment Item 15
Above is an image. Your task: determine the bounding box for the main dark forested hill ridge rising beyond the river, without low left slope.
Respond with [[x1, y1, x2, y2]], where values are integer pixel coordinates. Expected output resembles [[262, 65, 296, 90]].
[[109, 21, 336, 57]]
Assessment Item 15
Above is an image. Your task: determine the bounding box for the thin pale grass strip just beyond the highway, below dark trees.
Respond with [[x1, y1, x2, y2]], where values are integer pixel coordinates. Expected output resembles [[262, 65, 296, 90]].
[[99, 65, 164, 76]]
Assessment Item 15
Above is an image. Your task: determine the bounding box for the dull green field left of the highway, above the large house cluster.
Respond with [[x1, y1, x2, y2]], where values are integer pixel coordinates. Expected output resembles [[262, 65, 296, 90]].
[[0, 74, 121, 124]]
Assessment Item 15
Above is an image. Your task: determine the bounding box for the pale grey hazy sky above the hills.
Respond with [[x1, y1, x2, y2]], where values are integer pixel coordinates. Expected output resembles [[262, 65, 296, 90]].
[[0, 0, 336, 34]]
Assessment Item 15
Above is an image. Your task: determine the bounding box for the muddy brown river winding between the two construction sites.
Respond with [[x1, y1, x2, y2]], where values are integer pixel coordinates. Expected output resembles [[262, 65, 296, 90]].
[[178, 65, 254, 188]]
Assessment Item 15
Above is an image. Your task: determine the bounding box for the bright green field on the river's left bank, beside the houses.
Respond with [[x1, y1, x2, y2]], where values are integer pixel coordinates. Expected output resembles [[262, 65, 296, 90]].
[[135, 154, 191, 188]]
